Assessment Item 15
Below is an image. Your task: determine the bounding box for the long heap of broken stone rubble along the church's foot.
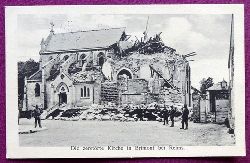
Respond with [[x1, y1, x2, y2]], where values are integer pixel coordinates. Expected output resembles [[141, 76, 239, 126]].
[[49, 102, 185, 122]]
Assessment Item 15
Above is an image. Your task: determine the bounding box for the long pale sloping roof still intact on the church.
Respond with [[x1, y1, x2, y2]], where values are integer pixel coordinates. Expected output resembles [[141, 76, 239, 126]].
[[42, 28, 125, 53]]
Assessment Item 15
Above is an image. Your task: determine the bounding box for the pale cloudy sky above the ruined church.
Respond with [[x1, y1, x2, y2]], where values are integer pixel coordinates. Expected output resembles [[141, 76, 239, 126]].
[[17, 14, 231, 88]]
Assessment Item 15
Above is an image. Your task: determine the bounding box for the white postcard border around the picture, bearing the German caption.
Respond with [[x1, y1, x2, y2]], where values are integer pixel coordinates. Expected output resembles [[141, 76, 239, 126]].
[[5, 4, 246, 158]]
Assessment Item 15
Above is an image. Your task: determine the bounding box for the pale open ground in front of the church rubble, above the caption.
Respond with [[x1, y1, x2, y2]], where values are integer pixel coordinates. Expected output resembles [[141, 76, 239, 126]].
[[19, 120, 235, 147]]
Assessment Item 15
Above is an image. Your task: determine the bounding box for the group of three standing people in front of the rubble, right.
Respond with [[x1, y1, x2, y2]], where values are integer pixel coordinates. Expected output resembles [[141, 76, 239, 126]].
[[162, 104, 189, 130]]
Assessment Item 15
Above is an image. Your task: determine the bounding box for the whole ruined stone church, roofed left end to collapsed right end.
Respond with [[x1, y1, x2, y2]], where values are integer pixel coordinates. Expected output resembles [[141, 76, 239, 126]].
[[23, 28, 191, 111]]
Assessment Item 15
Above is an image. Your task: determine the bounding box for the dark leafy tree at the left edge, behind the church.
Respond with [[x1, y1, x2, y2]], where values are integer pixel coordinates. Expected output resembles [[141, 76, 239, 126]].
[[17, 59, 39, 109]]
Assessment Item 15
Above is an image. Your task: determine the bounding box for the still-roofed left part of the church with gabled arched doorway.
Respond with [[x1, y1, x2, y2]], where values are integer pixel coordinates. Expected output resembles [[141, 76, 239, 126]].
[[24, 28, 125, 110]]
